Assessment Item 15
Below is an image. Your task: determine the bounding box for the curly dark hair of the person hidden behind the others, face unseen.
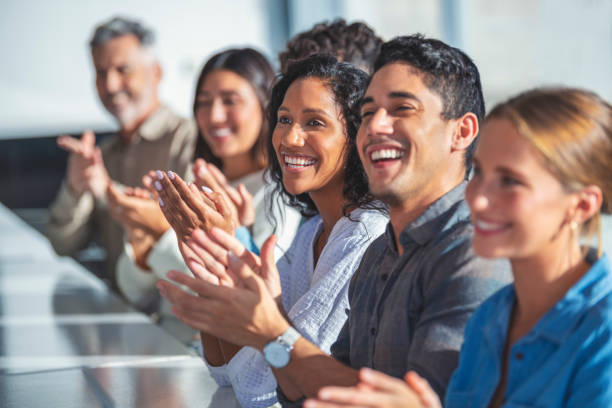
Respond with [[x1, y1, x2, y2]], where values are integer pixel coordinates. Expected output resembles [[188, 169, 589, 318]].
[[278, 19, 383, 73]]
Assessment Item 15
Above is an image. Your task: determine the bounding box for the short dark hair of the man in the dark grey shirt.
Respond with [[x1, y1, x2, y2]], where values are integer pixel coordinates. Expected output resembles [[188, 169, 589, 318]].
[[374, 34, 485, 177]]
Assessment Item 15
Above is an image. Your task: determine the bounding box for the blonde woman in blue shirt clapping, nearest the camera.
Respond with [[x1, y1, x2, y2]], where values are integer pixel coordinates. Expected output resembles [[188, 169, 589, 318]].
[[304, 88, 612, 408]]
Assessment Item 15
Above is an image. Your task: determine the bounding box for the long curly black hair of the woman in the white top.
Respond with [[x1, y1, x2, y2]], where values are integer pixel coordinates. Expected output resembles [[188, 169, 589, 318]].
[[267, 55, 385, 217]]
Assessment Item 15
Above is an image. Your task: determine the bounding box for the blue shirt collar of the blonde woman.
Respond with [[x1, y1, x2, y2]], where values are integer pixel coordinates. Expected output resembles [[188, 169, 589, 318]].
[[530, 250, 612, 343]]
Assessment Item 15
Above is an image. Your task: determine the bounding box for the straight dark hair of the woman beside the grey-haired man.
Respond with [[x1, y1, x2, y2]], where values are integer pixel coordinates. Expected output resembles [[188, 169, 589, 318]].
[[193, 48, 274, 170]]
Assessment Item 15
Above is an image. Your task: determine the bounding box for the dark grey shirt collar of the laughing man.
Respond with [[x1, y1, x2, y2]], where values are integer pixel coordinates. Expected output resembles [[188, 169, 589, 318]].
[[389, 181, 469, 248]]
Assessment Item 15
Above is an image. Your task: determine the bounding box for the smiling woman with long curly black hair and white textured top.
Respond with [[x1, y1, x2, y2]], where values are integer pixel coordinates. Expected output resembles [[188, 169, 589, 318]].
[[188, 56, 388, 407]]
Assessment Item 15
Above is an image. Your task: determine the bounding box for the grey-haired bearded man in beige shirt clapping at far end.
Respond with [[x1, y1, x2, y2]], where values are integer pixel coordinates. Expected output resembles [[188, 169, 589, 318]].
[[46, 17, 196, 287]]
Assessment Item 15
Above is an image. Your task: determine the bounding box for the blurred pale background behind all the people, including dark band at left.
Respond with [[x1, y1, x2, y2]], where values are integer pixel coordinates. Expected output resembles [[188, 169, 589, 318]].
[[0, 0, 612, 252]]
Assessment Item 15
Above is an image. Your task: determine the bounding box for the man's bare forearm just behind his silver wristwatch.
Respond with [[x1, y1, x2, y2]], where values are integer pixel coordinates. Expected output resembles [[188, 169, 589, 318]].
[[275, 337, 359, 401]]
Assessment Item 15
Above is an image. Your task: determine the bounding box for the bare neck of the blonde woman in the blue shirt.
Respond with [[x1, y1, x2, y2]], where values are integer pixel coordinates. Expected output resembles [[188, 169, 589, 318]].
[[510, 232, 589, 327]]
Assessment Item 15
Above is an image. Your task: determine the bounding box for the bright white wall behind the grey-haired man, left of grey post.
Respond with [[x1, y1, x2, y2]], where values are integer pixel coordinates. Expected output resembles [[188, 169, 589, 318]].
[[0, 0, 270, 138]]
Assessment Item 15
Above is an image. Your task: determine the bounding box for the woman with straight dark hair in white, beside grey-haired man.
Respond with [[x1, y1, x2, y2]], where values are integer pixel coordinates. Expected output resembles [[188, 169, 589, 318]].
[[113, 48, 301, 340]]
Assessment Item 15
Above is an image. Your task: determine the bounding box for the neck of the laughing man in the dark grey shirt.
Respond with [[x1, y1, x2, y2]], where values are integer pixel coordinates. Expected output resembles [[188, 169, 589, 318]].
[[389, 178, 463, 255]]
